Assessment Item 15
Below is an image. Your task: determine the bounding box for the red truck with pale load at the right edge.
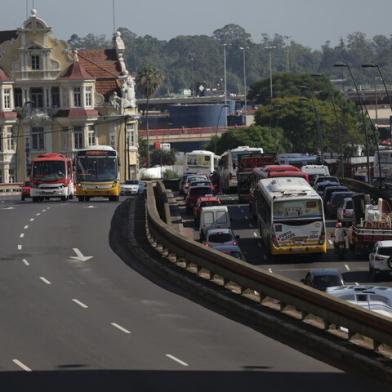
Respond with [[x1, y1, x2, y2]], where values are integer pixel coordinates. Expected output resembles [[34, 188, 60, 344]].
[[348, 193, 392, 254]]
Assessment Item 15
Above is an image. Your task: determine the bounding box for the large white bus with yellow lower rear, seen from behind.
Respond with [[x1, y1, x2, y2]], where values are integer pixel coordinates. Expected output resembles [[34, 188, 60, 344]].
[[255, 177, 327, 255]]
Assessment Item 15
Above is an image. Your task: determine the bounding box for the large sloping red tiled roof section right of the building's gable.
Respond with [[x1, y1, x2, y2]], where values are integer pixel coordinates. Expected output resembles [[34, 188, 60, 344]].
[[78, 49, 121, 98]]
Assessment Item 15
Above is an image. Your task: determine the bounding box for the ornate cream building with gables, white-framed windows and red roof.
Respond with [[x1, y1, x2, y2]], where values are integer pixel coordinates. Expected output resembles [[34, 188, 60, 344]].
[[0, 10, 139, 183]]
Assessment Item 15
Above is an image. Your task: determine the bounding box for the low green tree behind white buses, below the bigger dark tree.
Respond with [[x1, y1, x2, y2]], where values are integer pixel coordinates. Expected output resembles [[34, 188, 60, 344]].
[[205, 125, 291, 155]]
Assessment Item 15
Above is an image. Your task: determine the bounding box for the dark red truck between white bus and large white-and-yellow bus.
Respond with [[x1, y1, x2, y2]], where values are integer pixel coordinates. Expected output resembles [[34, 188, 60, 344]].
[[237, 152, 276, 203]]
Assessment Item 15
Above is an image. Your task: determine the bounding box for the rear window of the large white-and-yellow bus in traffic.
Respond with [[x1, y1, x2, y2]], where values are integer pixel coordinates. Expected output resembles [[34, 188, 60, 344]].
[[273, 199, 323, 221]]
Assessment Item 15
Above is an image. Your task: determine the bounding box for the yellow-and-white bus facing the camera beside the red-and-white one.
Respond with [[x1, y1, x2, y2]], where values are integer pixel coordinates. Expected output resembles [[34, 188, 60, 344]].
[[75, 146, 120, 201]]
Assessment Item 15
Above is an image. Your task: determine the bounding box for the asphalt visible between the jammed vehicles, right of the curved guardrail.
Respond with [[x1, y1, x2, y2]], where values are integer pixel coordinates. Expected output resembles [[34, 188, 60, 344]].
[[178, 195, 392, 287]]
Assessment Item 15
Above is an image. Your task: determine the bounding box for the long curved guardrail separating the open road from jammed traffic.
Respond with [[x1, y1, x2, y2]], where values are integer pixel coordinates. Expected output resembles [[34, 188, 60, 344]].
[[146, 183, 392, 353]]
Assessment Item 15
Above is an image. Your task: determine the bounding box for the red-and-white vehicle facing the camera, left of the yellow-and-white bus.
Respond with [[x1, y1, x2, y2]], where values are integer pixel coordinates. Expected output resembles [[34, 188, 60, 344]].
[[30, 153, 74, 202]]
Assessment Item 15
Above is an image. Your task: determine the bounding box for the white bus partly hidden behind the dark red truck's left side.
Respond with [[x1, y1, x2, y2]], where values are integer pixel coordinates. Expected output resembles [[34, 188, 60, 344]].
[[218, 146, 264, 193]]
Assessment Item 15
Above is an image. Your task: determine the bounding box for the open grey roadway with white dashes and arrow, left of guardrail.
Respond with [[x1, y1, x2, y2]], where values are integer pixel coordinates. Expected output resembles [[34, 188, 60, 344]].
[[0, 197, 382, 391]]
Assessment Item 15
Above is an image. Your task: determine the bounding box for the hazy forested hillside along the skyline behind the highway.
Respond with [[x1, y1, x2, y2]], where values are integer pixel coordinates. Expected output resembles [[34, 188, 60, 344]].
[[68, 24, 392, 95]]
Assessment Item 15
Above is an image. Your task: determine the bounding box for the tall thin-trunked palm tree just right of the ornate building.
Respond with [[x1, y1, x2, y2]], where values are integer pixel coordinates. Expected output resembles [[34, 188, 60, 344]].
[[136, 65, 163, 167]]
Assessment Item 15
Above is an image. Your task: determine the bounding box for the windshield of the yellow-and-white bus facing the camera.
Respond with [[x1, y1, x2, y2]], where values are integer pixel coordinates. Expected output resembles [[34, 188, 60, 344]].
[[76, 156, 117, 182]]
